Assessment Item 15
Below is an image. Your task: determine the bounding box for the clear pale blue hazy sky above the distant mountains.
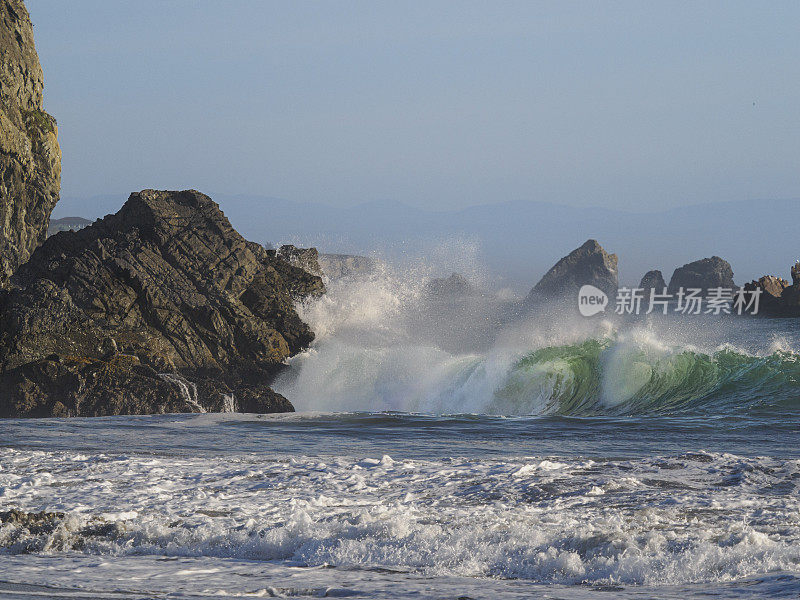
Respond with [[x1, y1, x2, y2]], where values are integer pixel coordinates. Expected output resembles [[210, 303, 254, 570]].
[[27, 0, 800, 210]]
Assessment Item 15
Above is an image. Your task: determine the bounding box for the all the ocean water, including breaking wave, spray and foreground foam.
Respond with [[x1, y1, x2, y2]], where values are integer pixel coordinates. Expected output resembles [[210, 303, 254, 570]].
[[0, 264, 800, 599]]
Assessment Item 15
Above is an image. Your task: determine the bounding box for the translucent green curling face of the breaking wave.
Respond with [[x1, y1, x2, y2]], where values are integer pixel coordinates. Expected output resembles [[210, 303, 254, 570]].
[[488, 339, 800, 416]]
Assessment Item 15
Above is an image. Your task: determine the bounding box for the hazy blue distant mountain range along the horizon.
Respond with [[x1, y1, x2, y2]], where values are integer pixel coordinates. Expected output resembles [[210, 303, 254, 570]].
[[54, 194, 800, 291]]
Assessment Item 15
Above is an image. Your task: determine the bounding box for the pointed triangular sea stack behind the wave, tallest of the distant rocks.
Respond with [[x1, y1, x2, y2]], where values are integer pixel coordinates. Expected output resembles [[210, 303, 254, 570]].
[[528, 240, 618, 302]]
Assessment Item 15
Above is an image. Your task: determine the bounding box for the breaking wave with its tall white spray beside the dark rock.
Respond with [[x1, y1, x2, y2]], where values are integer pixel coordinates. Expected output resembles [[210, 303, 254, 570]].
[[278, 258, 800, 416]]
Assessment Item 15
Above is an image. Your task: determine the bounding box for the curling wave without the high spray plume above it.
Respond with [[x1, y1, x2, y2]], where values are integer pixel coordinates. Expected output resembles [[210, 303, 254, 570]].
[[281, 331, 800, 416]]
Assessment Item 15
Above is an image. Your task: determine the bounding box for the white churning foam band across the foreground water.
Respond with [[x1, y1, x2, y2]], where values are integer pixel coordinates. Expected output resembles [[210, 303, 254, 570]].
[[0, 449, 800, 585]]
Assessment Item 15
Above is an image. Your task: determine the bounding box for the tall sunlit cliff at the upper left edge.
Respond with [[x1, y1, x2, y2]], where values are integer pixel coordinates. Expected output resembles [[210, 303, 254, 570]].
[[0, 0, 61, 287]]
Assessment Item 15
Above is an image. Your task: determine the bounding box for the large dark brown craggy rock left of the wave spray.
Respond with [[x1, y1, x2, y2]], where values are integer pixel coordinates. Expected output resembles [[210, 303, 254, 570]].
[[0, 190, 324, 416]]
